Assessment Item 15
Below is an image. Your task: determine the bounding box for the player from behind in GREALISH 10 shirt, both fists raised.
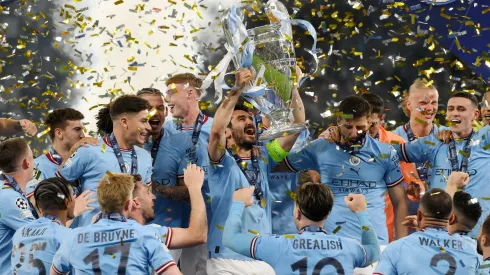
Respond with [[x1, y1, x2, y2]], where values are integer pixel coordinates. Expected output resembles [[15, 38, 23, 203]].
[[223, 183, 380, 275]]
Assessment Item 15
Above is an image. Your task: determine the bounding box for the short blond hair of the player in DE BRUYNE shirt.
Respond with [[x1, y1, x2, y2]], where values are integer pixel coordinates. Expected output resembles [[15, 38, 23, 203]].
[[97, 172, 135, 213]]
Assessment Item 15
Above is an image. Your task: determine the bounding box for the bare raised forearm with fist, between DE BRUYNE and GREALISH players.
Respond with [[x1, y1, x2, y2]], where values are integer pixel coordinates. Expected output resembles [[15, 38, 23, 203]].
[[169, 164, 208, 249]]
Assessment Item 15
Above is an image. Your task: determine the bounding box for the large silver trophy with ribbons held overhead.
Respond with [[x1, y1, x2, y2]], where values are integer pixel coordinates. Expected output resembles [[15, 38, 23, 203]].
[[222, 0, 305, 140]]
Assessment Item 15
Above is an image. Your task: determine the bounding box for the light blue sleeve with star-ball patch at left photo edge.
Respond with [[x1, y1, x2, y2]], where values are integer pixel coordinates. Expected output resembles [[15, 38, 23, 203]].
[[0, 195, 35, 230]]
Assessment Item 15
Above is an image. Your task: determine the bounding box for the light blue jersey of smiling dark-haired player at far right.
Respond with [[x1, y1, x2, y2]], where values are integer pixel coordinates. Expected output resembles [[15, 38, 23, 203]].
[[395, 125, 490, 237]]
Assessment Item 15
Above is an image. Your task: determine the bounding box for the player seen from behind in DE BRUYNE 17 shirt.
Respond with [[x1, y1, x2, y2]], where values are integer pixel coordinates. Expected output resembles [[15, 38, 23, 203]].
[[51, 172, 181, 275]]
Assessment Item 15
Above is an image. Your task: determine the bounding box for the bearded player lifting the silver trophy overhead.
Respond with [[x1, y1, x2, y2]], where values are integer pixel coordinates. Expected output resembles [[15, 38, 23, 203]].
[[207, 69, 304, 275]]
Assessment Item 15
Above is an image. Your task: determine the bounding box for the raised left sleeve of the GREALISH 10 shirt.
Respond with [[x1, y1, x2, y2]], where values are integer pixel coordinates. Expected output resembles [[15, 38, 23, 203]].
[[223, 201, 257, 258]]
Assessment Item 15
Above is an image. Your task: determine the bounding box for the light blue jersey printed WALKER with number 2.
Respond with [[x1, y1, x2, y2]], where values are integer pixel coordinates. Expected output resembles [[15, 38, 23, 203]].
[[373, 228, 480, 275]]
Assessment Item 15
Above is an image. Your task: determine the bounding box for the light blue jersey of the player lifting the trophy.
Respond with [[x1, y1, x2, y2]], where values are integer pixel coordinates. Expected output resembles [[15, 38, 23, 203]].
[[208, 146, 277, 261]]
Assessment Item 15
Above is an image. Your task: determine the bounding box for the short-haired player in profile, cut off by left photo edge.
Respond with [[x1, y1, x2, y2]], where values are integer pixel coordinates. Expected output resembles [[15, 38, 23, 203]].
[[0, 138, 35, 275]]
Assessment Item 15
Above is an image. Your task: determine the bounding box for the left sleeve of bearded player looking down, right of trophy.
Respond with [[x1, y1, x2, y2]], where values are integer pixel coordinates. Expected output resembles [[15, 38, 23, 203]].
[[285, 139, 328, 172]]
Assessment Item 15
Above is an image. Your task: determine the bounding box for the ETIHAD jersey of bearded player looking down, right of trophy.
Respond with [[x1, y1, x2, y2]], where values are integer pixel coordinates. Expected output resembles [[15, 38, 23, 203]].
[[286, 136, 403, 245]]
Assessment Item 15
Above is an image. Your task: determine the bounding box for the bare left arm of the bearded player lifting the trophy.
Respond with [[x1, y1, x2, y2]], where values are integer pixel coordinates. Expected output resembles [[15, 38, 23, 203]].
[[208, 69, 254, 161]]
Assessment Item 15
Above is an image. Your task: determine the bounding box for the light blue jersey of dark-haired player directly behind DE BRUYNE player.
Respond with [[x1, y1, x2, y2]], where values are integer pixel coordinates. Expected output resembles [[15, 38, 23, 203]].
[[56, 137, 152, 226]]
